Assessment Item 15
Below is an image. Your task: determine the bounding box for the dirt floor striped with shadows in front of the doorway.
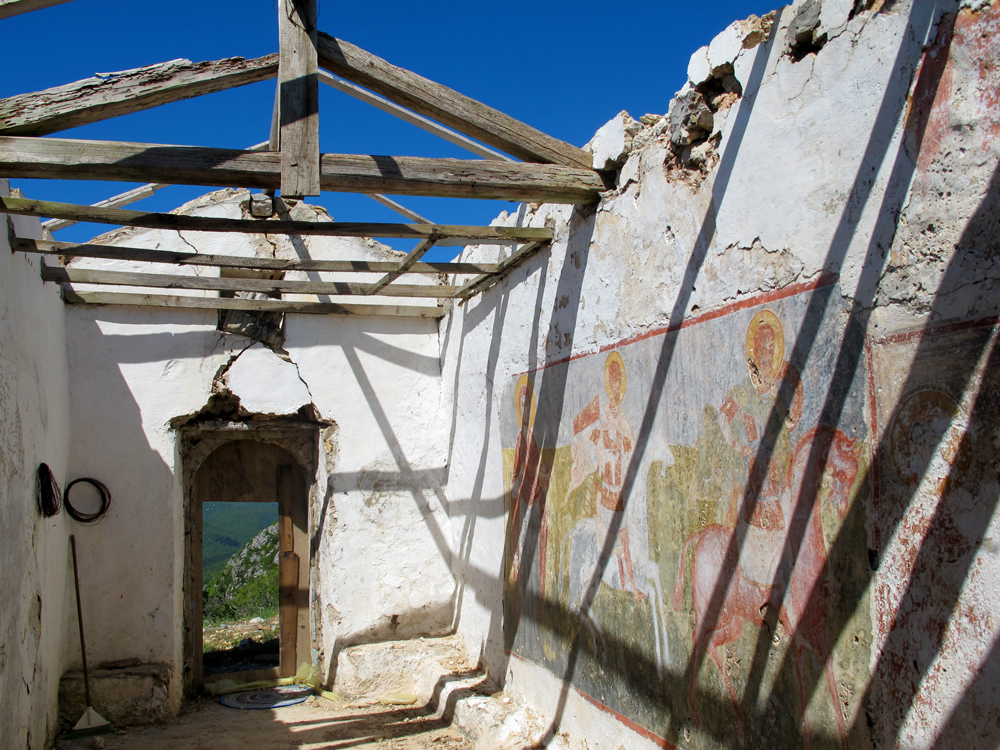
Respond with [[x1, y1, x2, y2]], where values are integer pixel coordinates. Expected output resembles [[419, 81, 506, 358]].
[[55, 697, 474, 750]]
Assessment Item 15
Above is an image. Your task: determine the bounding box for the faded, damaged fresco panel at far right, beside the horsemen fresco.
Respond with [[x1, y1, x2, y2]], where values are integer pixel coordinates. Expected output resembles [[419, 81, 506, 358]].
[[871, 319, 1000, 747]]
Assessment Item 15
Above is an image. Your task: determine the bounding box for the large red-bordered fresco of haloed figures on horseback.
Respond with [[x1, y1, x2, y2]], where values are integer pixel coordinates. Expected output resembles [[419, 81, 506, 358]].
[[501, 282, 871, 748]]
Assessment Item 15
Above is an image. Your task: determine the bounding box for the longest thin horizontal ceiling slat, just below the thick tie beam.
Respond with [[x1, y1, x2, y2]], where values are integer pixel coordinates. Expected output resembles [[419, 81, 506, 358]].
[[0, 195, 553, 244]]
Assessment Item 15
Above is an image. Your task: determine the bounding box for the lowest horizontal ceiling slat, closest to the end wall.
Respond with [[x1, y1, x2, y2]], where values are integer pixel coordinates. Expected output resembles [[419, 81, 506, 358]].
[[63, 286, 444, 318]]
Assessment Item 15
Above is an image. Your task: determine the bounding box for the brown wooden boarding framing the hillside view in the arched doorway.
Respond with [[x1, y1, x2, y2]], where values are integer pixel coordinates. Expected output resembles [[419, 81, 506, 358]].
[[184, 427, 316, 694]]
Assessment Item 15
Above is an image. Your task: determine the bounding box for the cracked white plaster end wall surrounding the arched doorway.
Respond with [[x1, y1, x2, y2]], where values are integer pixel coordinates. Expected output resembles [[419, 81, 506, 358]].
[[65, 191, 454, 708]]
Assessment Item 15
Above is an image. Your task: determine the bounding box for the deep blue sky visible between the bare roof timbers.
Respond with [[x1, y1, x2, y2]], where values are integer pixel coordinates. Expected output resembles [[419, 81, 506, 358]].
[[0, 0, 778, 260]]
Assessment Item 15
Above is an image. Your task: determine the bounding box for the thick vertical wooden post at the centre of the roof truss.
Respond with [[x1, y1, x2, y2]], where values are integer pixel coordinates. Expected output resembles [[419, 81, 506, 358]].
[[278, 0, 320, 198]]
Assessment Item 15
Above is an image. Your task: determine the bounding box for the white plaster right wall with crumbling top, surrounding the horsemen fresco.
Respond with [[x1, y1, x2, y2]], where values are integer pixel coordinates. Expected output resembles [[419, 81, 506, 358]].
[[442, 0, 1000, 750]]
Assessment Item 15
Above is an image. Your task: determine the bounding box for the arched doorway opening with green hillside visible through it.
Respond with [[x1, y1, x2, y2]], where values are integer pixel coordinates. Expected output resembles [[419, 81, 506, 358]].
[[185, 433, 311, 694]]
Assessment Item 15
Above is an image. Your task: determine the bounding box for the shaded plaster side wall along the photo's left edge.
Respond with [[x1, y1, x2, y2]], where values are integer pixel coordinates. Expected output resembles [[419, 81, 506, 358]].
[[0, 180, 75, 749]]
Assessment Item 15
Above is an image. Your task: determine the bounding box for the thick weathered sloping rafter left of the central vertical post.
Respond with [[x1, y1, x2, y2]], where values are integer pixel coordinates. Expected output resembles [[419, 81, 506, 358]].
[[0, 55, 278, 135]]
